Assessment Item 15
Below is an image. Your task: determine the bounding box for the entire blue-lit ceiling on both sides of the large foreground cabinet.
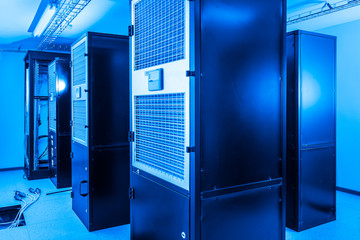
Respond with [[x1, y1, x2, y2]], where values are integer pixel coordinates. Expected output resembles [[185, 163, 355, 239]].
[[0, 0, 360, 44]]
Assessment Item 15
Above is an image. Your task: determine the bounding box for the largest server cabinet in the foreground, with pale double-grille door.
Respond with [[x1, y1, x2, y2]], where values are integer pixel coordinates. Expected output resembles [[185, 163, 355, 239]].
[[129, 0, 286, 240]]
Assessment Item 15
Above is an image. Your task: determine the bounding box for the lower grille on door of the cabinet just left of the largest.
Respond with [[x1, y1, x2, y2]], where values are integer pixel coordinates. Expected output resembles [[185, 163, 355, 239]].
[[73, 100, 87, 142]]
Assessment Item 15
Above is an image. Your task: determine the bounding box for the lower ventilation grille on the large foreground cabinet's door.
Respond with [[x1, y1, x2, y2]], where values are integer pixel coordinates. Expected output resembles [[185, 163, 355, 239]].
[[135, 93, 185, 180]]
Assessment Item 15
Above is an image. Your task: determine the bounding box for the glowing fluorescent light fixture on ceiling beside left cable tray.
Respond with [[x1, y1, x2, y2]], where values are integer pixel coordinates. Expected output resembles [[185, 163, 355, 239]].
[[28, 0, 58, 37]]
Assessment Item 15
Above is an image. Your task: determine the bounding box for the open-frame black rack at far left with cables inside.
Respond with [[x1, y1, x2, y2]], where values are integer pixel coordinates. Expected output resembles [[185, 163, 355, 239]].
[[24, 51, 69, 180]]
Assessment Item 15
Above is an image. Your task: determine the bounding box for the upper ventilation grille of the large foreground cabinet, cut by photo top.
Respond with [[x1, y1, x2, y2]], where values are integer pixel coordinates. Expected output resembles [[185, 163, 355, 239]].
[[135, 0, 185, 70]]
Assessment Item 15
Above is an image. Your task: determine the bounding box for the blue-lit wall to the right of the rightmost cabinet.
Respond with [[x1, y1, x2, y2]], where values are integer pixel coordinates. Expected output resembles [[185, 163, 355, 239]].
[[318, 21, 360, 191]]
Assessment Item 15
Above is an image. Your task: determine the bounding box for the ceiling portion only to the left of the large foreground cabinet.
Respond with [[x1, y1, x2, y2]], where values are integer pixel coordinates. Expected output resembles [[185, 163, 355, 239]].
[[0, 0, 130, 44]]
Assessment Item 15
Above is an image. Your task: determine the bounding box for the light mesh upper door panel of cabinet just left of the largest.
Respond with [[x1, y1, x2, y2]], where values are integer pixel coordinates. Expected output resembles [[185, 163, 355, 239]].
[[72, 38, 88, 146]]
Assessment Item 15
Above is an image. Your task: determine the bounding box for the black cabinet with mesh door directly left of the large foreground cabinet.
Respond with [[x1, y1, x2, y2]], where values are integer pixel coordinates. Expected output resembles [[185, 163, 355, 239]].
[[71, 32, 130, 231]]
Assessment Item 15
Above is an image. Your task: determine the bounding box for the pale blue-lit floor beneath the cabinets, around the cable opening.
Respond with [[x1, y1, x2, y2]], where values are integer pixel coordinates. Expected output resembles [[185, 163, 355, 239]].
[[0, 171, 360, 240]]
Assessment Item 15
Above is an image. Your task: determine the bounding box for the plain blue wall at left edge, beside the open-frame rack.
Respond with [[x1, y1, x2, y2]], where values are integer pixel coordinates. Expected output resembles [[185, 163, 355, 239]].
[[0, 51, 25, 169]]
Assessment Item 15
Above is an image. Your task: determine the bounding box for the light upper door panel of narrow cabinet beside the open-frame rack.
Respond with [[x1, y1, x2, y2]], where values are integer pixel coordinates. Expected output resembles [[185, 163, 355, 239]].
[[48, 62, 56, 132]]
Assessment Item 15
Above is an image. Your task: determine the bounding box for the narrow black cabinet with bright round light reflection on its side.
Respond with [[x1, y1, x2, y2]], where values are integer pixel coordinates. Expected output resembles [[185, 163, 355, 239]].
[[48, 55, 71, 188]]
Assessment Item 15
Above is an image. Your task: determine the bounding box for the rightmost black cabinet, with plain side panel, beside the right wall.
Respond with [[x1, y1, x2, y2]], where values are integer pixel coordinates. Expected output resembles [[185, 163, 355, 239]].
[[286, 31, 336, 231]]
